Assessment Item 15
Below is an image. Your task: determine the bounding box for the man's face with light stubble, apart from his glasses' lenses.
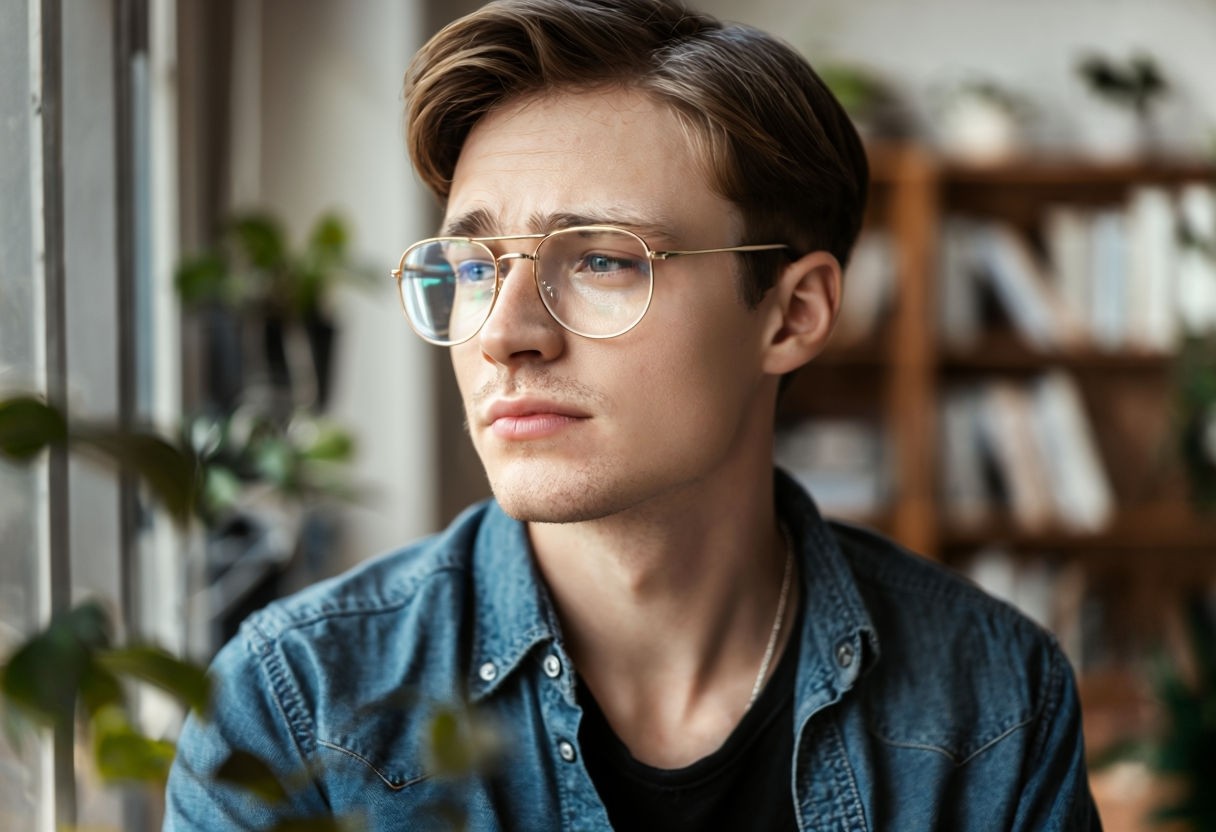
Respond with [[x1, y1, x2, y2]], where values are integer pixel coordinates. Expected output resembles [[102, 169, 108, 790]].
[[445, 90, 773, 522]]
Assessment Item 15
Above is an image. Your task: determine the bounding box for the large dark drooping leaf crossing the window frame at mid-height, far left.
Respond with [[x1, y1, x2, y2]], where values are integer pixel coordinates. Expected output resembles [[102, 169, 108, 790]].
[[72, 427, 197, 525]]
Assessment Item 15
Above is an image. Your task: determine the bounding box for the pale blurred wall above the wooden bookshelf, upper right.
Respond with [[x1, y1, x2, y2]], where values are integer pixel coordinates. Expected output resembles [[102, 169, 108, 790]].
[[693, 0, 1216, 152]]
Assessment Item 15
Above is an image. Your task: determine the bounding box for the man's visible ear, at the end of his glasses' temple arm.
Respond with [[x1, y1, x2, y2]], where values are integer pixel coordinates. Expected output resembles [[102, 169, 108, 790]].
[[764, 252, 841, 376]]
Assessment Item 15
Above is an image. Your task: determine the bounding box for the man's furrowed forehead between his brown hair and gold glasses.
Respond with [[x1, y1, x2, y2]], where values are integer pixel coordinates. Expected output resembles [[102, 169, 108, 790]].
[[445, 88, 738, 236]]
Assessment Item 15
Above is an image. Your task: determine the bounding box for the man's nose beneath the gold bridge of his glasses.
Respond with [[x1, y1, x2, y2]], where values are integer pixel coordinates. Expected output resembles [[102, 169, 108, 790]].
[[478, 254, 567, 365]]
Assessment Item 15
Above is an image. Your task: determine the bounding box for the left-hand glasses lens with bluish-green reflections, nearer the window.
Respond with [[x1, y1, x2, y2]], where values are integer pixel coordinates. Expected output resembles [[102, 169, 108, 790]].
[[400, 240, 497, 344]]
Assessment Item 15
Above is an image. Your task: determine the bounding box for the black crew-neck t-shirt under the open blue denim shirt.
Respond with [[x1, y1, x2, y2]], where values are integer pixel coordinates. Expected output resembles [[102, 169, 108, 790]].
[[579, 603, 801, 832]]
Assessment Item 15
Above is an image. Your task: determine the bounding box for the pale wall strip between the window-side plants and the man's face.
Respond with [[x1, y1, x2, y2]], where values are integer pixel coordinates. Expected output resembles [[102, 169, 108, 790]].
[[255, 0, 437, 567]]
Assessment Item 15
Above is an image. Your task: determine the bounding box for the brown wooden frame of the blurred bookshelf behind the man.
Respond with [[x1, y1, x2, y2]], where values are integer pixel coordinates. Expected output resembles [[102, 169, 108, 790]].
[[781, 145, 1216, 807]]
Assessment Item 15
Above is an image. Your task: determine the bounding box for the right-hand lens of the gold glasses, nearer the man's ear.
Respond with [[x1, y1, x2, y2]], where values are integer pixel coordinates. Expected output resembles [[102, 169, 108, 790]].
[[536, 227, 652, 338]]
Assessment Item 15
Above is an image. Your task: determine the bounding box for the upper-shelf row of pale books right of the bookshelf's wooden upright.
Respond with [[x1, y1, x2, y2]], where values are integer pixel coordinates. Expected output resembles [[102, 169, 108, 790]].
[[939, 184, 1216, 353]]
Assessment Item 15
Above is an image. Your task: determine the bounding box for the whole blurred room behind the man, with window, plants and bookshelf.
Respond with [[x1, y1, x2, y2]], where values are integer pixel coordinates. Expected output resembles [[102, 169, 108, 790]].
[[0, 0, 1216, 830]]
